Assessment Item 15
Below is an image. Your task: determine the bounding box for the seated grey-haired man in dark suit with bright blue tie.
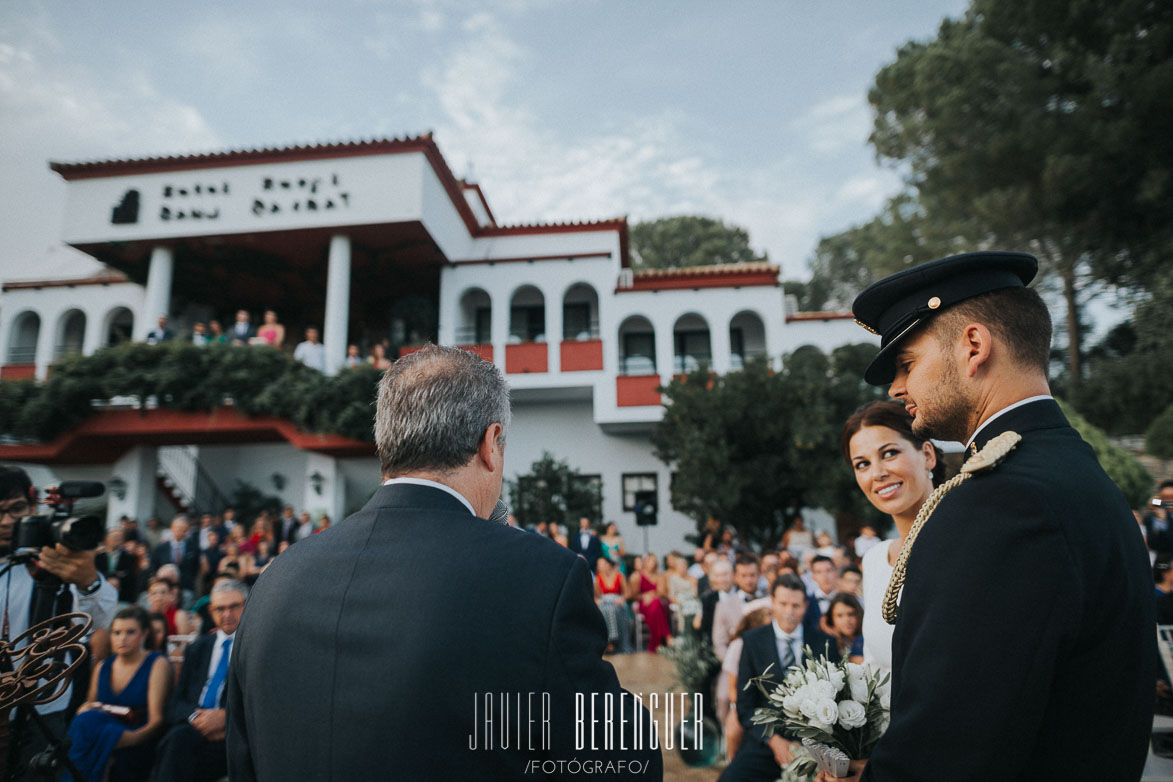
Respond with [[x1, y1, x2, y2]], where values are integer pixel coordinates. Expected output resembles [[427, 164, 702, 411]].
[[150, 580, 246, 782]]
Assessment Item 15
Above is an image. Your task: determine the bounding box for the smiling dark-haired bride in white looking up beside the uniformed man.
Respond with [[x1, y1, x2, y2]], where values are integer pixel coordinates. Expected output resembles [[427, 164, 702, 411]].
[[840, 401, 944, 673]]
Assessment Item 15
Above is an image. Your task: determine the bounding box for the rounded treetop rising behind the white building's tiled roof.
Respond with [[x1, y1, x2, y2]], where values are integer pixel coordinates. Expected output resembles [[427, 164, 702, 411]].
[[630, 215, 767, 268]]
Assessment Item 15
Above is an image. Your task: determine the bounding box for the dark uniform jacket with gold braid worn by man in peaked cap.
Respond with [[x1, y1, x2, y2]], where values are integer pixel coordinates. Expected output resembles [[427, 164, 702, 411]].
[[863, 400, 1157, 782]]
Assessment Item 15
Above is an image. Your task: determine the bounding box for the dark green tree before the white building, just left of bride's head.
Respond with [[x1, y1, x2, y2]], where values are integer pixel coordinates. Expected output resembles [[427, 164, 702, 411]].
[[652, 345, 882, 544]]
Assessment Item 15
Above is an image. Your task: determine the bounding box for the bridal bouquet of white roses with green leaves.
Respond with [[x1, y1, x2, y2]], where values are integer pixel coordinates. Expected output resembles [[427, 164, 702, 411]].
[[746, 647, 891, 778]]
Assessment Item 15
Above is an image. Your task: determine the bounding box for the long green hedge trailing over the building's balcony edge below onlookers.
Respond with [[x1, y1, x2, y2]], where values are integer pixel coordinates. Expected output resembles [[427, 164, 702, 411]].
[[0, 342, 381, 442]]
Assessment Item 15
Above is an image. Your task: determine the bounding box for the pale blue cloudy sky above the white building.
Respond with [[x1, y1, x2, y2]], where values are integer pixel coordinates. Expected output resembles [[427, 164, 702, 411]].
[[0, 0, 967, 279]]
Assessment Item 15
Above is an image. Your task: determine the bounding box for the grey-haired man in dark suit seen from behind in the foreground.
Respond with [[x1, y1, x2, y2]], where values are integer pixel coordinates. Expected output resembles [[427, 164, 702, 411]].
[[228, 346, 663, 782]]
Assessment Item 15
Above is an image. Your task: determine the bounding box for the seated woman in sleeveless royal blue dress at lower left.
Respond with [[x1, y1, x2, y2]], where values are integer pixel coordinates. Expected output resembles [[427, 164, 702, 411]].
[[63, 606, 171, 782]]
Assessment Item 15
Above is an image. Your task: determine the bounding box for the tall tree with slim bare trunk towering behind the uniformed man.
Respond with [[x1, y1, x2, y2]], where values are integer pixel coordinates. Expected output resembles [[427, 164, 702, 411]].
[[853, 0, 1173, 385]]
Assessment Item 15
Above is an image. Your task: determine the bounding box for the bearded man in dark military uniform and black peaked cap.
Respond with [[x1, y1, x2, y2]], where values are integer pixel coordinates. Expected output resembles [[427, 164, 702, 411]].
[[854, 252, 1157, 782]]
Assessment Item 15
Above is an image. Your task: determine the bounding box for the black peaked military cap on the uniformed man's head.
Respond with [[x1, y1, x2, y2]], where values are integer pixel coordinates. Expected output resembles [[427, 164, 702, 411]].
[[852, 251, 1038, 386]]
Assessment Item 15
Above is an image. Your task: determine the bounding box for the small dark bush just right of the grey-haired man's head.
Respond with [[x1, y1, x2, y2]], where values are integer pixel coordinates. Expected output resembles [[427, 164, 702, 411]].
[[509, 451, 603, 531]]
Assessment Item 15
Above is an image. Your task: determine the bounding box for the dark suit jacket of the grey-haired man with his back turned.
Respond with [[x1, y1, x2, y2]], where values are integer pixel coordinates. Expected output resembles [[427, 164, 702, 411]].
[[228, 484, 663, 782]]
